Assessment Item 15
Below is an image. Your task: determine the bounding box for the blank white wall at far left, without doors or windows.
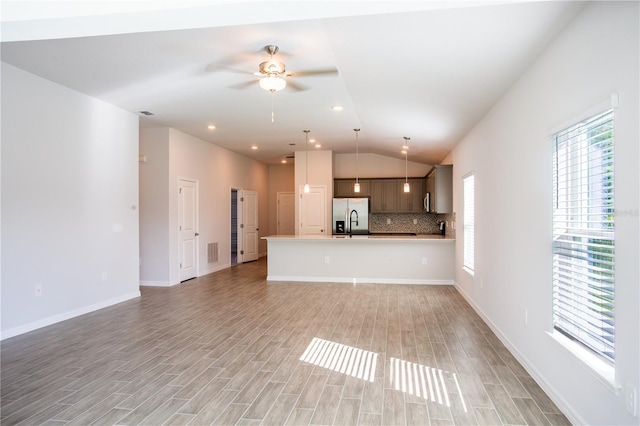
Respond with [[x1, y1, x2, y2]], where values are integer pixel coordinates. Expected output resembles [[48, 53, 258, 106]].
[[1, 63, 140, 338]]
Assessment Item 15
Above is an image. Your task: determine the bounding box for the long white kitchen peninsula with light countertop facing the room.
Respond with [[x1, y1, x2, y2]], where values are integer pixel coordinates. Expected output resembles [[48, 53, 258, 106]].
[[263, 235, 455, 284]]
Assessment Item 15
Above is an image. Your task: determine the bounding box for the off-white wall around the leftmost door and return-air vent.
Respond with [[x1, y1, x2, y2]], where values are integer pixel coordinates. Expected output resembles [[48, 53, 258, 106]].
[[140, 128, 269, 285]]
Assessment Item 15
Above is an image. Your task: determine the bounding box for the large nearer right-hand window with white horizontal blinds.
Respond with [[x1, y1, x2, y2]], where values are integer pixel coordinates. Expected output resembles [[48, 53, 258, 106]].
[[553, 110, 615, 361]]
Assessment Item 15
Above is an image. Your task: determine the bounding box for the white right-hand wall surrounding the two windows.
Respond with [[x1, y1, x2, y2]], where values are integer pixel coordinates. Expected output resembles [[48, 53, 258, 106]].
[[448, 2, 640, 425]]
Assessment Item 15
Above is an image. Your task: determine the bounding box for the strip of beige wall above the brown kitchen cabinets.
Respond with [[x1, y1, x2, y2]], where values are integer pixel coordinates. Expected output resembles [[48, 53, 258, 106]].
[[333, 154, 433, 179]]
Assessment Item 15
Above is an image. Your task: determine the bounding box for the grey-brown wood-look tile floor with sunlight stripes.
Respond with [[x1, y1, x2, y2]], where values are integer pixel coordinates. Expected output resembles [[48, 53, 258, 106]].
[[0, 259, 569, 425]]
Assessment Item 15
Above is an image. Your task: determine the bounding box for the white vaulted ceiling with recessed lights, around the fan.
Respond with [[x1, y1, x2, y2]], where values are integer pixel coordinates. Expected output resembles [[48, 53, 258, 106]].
[[1, 0, 583, 164]]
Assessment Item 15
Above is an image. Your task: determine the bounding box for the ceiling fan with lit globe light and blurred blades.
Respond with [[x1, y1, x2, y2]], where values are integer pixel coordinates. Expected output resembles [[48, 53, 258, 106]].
[[207, 44, 338, 93]]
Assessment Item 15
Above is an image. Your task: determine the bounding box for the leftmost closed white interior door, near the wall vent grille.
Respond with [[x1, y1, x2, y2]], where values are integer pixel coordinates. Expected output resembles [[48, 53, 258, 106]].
[[178, 179, 198, 281]]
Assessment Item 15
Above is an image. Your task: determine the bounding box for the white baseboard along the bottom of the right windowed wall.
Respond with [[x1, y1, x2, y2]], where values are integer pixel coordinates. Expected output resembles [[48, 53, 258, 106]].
[[454, 282, 587, 425]]
